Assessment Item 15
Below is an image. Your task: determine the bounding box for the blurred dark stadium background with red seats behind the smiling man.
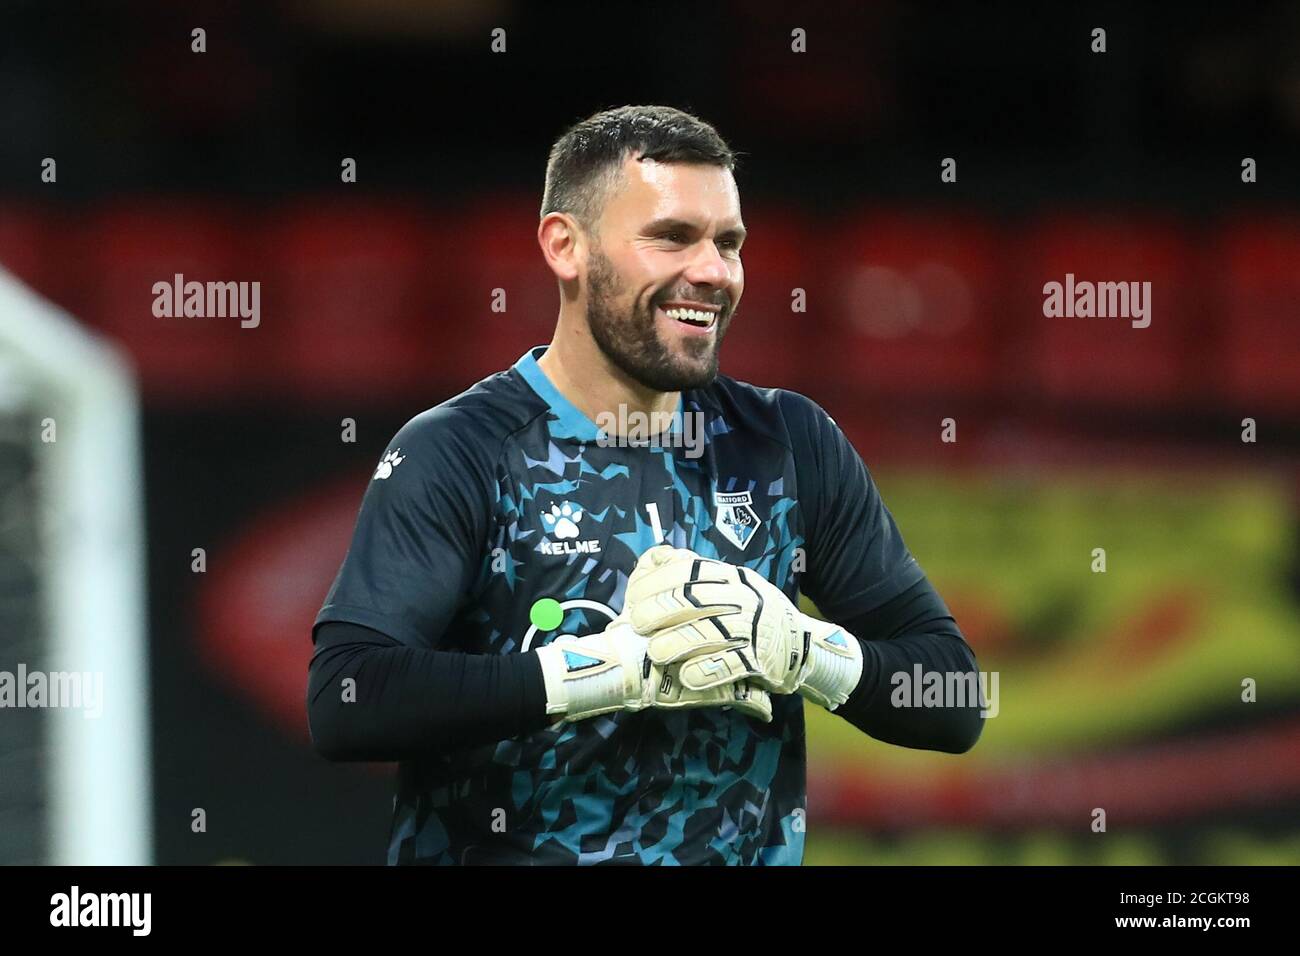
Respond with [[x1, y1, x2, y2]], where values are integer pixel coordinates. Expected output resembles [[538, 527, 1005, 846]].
[[0, 0, 1300, 864]]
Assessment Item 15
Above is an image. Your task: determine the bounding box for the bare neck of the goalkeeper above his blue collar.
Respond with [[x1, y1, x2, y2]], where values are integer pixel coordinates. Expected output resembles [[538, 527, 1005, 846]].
[[537, 332, 681, 434]]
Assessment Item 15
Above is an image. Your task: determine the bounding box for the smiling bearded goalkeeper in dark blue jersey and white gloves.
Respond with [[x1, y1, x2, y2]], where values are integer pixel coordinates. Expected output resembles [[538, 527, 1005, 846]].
[[308, 107, 982, 865]]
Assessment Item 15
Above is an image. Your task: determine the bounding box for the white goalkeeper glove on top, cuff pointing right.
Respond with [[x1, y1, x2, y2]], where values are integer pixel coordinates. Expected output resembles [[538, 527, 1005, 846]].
[[623, 545, 862, 710]]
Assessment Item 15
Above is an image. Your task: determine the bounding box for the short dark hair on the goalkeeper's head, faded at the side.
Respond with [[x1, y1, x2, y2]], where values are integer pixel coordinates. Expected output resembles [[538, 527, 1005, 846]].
[[542, 107, 737, 234]]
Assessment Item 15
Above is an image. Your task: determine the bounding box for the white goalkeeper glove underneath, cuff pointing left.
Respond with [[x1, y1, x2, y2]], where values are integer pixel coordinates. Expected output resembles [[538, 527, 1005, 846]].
[[537, 617, 772, 723]]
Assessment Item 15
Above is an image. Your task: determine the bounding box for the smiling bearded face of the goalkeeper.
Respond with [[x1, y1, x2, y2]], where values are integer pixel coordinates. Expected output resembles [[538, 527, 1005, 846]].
[[586, 157, 745, 392]]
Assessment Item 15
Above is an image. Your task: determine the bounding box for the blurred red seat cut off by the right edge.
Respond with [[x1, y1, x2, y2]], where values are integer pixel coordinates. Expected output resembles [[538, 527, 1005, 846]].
[[1216, 219, 1300, 412]]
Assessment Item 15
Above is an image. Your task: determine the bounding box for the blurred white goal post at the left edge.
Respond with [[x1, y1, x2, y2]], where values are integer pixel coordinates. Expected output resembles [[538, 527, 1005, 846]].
[[0, 268, 153, 865]]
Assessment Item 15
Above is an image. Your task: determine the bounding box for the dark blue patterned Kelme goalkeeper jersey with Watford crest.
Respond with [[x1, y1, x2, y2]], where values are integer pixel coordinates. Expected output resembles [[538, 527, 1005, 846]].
[[316, 347, 924, 865]]
